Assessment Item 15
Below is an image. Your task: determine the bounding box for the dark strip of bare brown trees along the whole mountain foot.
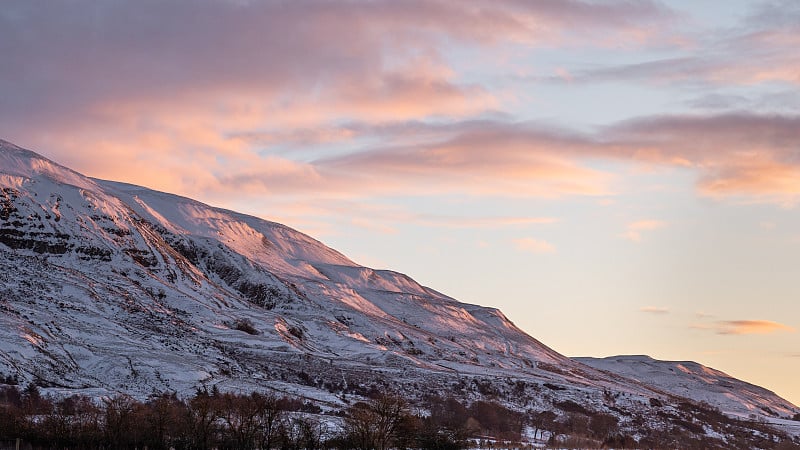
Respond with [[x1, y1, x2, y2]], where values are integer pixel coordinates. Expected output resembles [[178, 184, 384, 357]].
[[0, 384, 800, 450]]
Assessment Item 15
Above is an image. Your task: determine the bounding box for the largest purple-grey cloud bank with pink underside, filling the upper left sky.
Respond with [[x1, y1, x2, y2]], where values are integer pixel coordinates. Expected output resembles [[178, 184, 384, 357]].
[[0, 0, 672, 129]]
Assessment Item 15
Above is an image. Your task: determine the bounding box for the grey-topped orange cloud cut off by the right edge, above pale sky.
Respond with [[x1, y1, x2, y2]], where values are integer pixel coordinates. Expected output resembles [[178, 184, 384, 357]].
[[606, 113, 800, 204]]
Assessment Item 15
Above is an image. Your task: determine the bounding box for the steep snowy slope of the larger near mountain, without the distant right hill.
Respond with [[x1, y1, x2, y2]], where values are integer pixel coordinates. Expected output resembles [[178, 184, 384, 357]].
[[0, 137, 607, 392]]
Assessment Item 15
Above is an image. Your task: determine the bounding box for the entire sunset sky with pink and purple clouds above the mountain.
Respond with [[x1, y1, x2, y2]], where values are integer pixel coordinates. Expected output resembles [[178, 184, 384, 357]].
[[0, 0, 800, 405]]
